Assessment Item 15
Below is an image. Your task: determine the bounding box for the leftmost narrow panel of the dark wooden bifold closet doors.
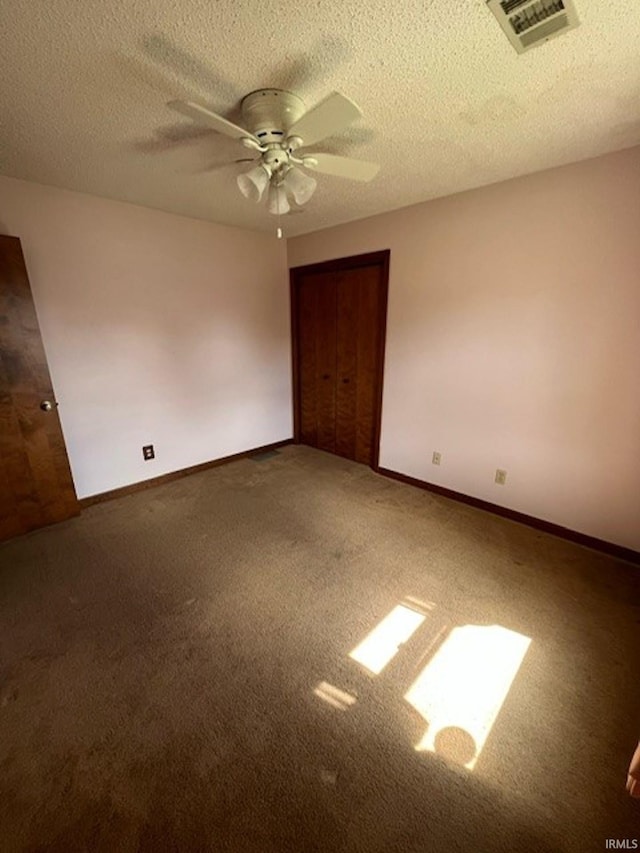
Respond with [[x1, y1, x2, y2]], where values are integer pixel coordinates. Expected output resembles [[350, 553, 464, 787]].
[[297, 276, 318, 447]]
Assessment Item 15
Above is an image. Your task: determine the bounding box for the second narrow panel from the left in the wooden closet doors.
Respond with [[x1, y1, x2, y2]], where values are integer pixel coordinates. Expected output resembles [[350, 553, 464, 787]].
[[315, 273, 337, 453]]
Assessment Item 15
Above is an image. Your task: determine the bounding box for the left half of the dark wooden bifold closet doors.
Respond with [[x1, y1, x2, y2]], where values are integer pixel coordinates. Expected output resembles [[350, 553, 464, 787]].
[[297, 273, 337, 453]]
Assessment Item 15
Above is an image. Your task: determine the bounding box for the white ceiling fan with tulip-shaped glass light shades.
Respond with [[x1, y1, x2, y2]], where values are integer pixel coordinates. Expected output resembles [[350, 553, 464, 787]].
[[168, 89, 380, 215]]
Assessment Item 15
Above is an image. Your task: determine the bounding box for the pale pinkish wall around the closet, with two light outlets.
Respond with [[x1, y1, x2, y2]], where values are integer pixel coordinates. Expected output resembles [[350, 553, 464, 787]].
[[288, 148, 640, 549]]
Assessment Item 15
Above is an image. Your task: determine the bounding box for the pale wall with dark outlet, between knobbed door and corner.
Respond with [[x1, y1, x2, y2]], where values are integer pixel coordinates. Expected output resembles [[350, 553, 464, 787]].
[[0, 177, 292, 497]]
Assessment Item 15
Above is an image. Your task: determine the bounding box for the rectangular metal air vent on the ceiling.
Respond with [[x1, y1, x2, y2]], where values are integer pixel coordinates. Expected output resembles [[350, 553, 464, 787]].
[[487, 0, 580, 53]]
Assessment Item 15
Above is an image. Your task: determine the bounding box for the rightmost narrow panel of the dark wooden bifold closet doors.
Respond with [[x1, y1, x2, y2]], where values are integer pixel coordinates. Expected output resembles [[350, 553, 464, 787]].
[[352, 266, 382, 464]]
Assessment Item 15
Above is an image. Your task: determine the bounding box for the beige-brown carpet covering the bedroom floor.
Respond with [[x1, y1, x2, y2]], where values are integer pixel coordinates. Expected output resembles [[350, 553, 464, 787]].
[[0, 447, 640, 853]]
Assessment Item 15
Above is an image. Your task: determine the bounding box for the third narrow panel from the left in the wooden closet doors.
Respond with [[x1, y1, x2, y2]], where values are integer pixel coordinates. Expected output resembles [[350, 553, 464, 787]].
[[335, 270, 359, 459]]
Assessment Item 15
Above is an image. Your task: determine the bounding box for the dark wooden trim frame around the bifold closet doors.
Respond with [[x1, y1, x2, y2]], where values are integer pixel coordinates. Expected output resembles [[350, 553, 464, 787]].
[[289, 249, 391, 471]]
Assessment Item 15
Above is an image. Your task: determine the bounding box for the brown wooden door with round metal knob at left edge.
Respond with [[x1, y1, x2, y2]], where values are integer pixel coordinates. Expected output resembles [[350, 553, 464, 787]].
[[0, 236, 80, 540]]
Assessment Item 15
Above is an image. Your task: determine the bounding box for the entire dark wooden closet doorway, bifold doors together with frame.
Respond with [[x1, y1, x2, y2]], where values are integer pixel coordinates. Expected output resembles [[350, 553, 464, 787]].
[[291, 252, 389, 467]]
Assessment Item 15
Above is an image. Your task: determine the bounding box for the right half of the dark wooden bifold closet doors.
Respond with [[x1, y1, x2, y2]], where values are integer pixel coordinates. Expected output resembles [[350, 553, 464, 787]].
[[335, 265, 382, 464]]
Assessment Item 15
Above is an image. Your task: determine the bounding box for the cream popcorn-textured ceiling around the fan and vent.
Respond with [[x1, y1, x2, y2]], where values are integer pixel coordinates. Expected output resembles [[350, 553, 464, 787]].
[[0, 0, 640, 235]]
